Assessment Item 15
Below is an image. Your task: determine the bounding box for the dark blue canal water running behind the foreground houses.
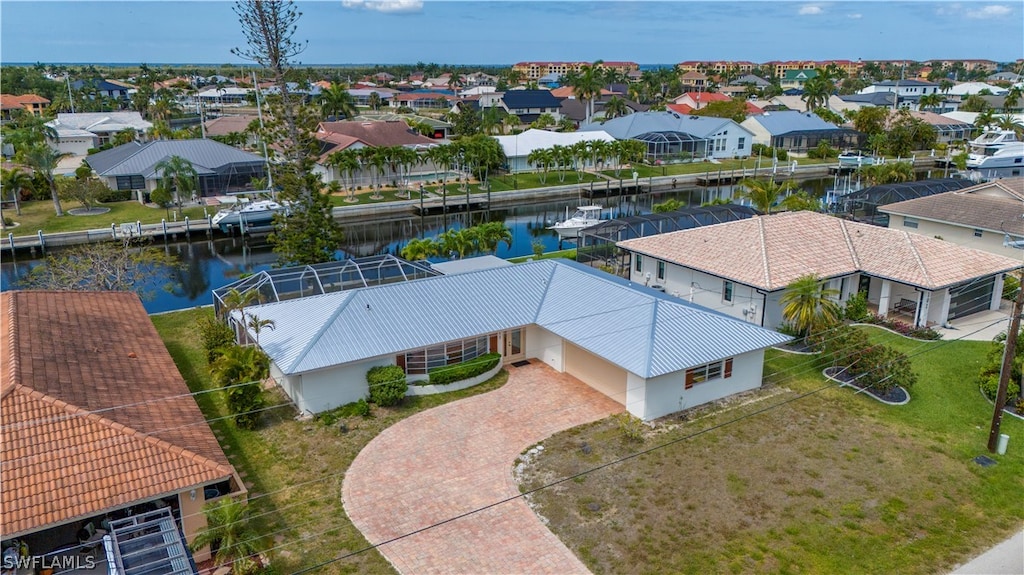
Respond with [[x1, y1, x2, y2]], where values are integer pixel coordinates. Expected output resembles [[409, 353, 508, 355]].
[[0, 178, 834, 313]]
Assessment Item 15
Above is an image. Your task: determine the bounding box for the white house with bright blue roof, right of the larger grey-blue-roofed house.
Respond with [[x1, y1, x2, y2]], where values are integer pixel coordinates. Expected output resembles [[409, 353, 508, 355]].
[[741, 112, 863, 151]]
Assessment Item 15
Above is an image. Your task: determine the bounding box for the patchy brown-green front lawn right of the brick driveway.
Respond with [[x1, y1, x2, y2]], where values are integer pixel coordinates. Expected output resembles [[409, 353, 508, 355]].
[[520, 327, 1024, 574]]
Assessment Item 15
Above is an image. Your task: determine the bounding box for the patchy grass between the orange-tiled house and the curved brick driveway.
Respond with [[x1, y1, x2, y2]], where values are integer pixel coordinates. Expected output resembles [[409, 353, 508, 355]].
[[153, 309, 507, 574]]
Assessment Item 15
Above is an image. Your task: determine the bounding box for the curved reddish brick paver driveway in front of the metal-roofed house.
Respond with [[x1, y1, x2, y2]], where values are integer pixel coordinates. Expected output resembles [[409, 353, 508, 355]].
[[342, 360, 623, 575]]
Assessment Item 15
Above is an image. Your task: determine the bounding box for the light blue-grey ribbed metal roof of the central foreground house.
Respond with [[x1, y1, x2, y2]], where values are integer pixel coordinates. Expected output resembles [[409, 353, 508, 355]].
[[243, 260, 788, 378]]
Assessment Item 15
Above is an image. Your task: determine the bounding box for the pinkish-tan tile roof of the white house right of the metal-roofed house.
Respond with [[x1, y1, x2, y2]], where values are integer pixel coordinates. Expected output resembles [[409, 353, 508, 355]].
[[618, 212, 1021, 292]]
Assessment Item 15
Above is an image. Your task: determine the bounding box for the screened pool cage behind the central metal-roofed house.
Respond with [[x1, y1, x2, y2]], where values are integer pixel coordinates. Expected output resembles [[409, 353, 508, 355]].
[[213, 254, 441, 317]]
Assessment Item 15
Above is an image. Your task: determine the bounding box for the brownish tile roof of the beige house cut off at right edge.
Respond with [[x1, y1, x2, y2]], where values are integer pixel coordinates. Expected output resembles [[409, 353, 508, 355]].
[[879, 178, 1024, 236]]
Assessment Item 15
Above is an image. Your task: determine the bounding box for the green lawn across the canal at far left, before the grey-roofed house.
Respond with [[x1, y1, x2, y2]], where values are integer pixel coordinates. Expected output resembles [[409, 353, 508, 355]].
[[3, 200, 207, 236]]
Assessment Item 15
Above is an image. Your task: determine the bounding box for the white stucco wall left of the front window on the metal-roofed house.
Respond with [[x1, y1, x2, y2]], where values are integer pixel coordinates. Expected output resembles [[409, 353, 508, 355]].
[[279, 355, 394, 413]]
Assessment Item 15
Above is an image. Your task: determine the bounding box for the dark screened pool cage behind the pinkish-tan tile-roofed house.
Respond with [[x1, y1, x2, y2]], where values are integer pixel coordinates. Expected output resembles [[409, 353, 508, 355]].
[[577, 204, 759, 277]]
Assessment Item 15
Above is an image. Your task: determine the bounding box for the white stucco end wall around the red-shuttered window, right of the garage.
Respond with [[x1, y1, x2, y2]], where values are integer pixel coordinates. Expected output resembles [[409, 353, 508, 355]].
[[627, 350, 764, 419]]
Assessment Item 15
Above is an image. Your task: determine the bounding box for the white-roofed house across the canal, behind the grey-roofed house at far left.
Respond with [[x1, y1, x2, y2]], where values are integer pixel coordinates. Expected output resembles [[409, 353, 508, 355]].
[[46, 112, 153, 156]]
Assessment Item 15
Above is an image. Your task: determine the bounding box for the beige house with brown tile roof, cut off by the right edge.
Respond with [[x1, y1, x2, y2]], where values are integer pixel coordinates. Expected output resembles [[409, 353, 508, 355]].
[[879, 178, 1024, 255]]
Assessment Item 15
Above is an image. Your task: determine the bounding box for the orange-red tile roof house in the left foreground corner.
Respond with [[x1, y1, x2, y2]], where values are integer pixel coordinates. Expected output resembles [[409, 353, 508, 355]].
[[0, 292, 245, 573]]
